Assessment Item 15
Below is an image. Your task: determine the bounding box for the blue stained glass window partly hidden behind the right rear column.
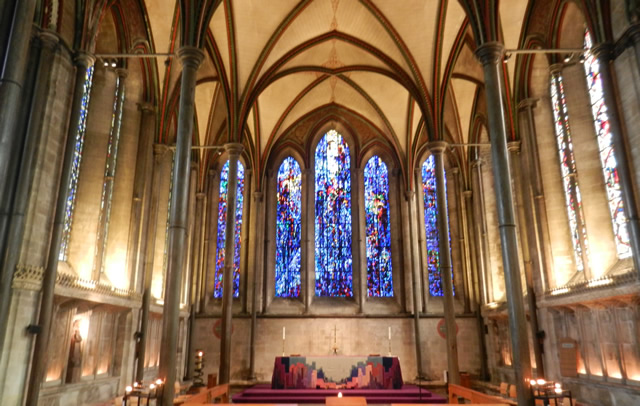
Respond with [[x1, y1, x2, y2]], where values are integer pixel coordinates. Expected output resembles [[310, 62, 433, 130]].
[[422, 155, 455, 296]]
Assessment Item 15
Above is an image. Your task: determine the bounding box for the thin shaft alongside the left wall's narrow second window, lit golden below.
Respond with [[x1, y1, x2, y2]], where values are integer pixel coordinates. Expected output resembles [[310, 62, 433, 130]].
[[93, 68, 127, 280]]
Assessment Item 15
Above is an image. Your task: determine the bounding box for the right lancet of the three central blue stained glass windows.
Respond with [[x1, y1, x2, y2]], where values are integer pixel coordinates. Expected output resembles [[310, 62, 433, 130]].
[[364, 156, 393, 297]]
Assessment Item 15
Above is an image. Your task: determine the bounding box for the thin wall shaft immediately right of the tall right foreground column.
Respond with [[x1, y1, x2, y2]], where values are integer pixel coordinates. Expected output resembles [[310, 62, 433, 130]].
[[508, 141, 544, 378]]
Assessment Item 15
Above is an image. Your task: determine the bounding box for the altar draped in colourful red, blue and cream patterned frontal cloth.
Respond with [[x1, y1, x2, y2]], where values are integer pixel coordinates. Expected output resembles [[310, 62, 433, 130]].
[[271, 355, 403, 389]]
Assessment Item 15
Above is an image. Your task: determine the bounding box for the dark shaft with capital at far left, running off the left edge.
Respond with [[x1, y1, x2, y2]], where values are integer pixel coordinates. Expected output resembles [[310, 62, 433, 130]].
[[0, 32, 59, 349]]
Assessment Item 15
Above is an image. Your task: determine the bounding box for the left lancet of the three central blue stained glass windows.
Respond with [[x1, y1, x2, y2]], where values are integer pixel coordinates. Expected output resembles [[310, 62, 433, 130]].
[[276, 157, 302, 297]]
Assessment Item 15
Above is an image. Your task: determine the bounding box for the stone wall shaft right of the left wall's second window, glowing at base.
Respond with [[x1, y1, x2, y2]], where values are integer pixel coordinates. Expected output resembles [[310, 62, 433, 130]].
[[127, 103, 156, 290]]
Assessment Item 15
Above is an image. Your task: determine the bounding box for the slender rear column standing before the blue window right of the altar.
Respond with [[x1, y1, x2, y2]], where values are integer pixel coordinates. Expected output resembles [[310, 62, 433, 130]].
[[428, 141, 460, 385]]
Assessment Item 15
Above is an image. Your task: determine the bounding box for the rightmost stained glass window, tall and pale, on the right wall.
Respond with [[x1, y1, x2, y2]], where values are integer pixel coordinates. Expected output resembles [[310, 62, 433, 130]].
[[584, 30, 631, 258]]
